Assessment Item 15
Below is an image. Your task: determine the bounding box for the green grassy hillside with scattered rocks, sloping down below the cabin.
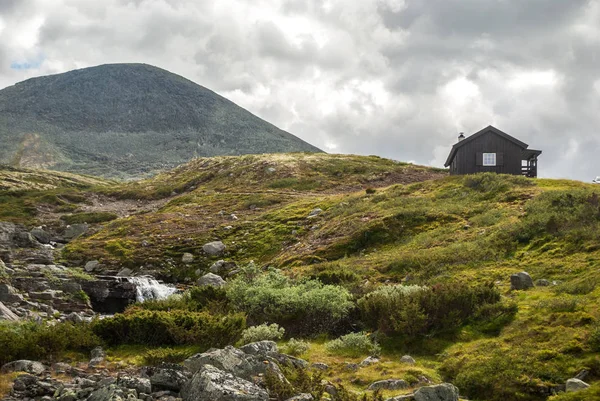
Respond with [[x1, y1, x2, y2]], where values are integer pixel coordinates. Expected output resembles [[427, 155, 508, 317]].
[[0, 154, 600, 401]]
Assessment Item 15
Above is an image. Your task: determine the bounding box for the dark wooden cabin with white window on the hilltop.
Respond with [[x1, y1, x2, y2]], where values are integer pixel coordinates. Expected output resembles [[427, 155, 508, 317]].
[[444, 125, 542, 177]]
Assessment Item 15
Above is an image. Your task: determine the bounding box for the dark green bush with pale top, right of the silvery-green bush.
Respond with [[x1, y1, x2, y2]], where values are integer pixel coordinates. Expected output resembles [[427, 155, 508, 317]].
[[358, 283, 500, 338]]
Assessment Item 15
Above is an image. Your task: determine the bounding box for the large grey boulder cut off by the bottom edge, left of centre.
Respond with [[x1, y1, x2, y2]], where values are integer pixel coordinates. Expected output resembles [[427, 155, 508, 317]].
[[181, 365, 269, 401]]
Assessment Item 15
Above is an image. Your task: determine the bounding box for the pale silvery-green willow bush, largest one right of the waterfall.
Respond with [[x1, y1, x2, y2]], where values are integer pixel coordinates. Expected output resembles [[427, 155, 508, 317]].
[[226, 266, 353, 336]]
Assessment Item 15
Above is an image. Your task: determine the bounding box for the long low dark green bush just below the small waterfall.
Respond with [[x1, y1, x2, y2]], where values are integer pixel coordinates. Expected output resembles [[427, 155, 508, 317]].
[[92, 308, 246, 348]]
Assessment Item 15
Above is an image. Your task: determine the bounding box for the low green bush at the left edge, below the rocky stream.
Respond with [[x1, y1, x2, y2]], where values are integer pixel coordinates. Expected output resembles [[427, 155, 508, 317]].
[[0, 322, 101, 365]]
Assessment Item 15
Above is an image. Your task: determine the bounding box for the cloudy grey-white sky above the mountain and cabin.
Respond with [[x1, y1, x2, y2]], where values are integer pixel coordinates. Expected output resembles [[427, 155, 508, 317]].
[[0, 0, 600, 181]]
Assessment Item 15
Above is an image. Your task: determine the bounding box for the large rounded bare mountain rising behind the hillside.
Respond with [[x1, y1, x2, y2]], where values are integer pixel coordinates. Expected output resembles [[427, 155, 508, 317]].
[[0, 64, 320, 178]]
